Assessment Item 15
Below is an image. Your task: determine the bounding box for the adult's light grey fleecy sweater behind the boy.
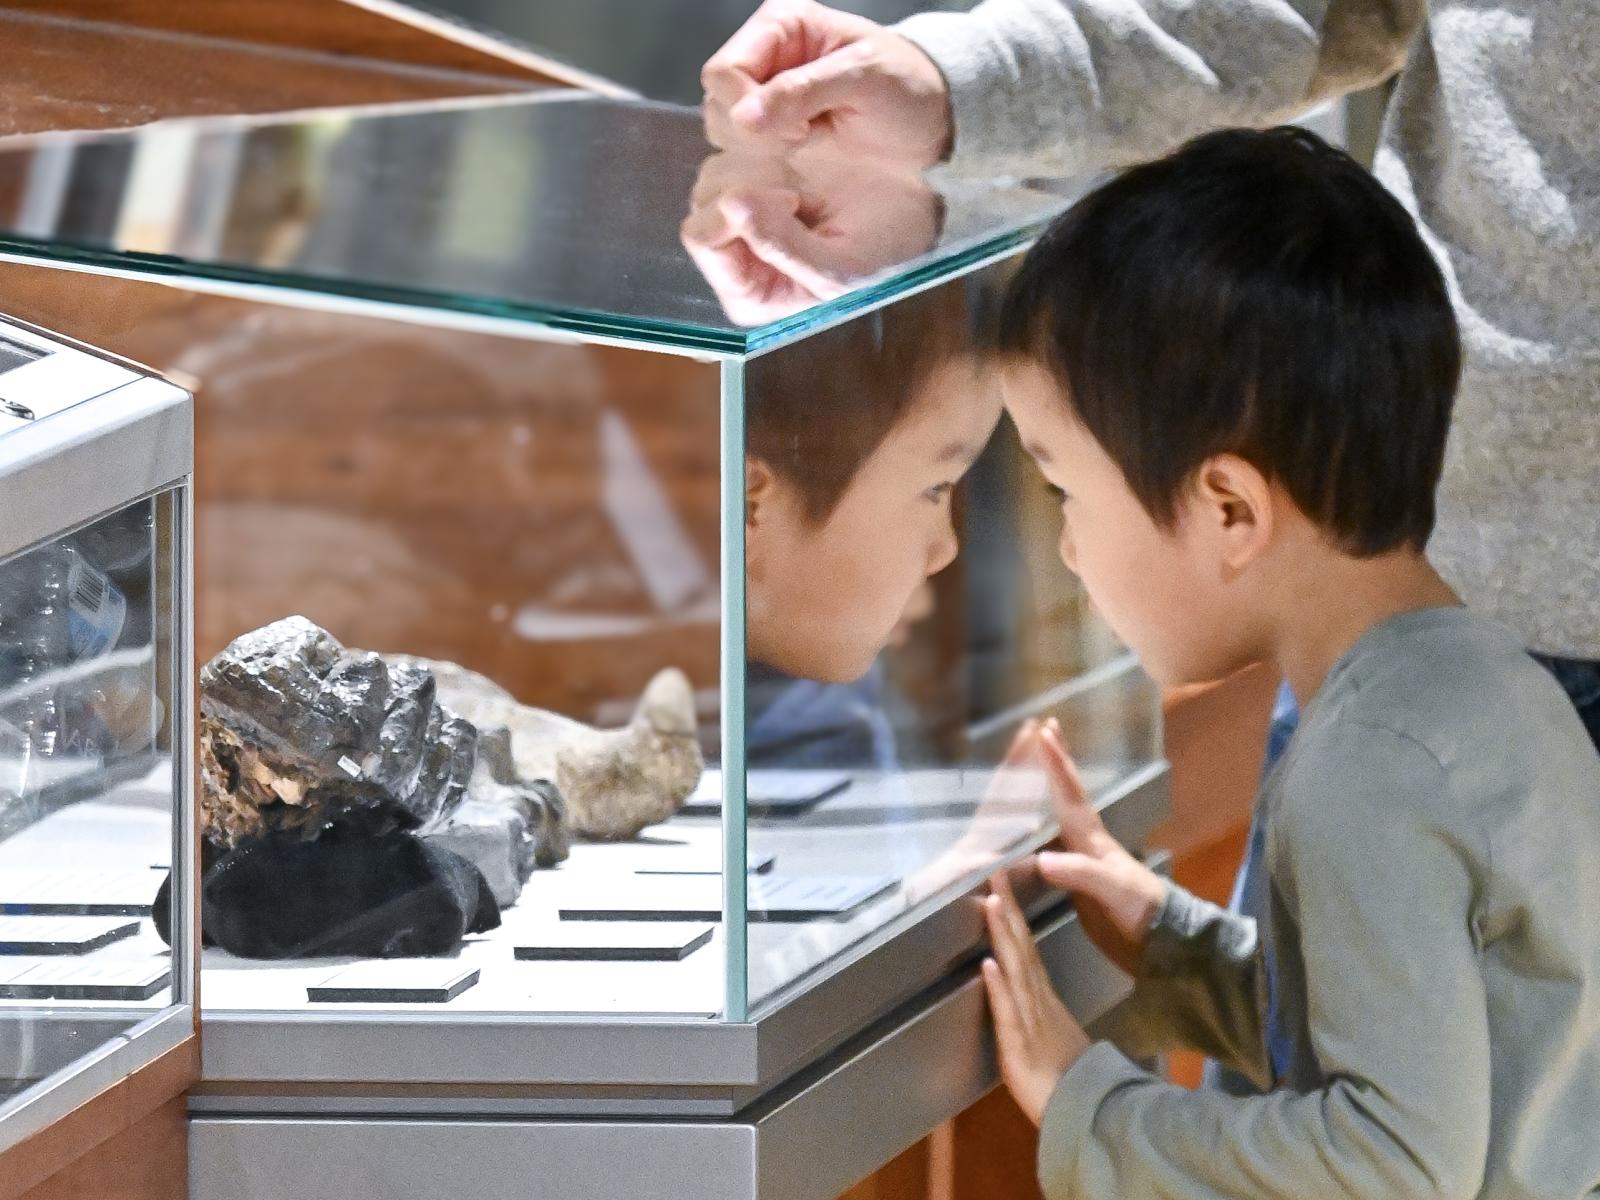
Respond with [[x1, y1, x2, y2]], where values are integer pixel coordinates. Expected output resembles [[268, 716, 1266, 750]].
[[899, 0, 1600, 658]]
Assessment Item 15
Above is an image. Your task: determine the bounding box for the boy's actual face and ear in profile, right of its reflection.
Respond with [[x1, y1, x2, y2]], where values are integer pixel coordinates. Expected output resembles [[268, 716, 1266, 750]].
[[1003, 363, 1251, 683]]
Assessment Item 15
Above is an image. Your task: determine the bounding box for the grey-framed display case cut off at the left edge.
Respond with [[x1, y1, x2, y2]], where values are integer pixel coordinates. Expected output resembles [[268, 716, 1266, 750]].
[[0, 318, 195, 1149]]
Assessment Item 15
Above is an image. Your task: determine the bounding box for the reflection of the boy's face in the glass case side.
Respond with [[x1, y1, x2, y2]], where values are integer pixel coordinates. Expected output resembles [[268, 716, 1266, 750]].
[[746, 363, 1000, 683]]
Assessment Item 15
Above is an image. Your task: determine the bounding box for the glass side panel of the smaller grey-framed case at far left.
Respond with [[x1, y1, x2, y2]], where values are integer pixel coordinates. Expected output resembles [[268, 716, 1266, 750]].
[[0, 494, 187, 1093]]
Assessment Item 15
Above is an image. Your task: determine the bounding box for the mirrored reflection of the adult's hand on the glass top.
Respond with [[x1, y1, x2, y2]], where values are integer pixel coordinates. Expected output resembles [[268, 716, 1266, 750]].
[[680, 149, 942, 325]]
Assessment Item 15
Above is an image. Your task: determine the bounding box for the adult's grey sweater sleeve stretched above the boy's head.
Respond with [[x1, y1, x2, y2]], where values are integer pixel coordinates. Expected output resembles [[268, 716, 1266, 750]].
[[896, 0, 1427, 176]]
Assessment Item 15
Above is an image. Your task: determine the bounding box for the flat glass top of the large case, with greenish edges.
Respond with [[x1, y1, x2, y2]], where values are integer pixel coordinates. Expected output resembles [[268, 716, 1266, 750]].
[[0, 91, 1069, 354]]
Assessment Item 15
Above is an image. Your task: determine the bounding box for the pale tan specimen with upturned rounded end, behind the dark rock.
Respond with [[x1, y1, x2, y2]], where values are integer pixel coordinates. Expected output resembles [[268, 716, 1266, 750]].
[[389, 658, 704, 842]]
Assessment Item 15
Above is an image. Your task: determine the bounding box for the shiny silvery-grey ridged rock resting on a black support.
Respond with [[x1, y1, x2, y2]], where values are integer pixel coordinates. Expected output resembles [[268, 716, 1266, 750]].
[[200, 616, 478, 846]]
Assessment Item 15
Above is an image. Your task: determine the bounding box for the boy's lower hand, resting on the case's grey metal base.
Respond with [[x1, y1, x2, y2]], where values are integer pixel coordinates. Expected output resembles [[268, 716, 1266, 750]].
[[982, 874, 1090, 1125]]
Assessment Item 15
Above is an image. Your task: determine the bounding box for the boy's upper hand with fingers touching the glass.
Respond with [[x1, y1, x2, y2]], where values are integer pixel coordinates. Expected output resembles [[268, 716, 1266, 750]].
[[1038, 718, 1166, 974]]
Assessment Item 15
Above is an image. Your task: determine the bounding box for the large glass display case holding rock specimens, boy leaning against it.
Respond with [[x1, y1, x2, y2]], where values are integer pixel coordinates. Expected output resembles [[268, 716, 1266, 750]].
[[0, 93, 1166, 1197]]
